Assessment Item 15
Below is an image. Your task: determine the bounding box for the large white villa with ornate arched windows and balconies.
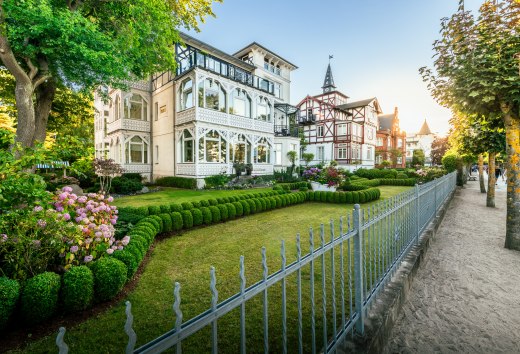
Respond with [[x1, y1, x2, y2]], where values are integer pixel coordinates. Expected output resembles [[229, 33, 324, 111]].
[[94, 33, 300, 180]]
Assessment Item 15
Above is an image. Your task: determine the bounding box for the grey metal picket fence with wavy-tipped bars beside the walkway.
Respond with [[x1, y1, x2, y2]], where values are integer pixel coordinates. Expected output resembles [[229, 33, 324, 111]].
[[56, 173, 456, 353]]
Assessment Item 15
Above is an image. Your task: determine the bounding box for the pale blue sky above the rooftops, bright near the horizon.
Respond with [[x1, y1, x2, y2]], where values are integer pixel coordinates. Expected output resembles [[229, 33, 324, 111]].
[[188, 0, 482, 135]]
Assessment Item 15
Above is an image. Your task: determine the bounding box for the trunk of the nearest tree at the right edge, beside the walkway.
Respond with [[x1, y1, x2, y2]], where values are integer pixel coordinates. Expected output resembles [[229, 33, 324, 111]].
[[500, 104, 520, 251]]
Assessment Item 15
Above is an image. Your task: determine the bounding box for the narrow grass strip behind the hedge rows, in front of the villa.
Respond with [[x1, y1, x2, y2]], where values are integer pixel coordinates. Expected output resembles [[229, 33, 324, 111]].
[[113, 187, 272, 207]]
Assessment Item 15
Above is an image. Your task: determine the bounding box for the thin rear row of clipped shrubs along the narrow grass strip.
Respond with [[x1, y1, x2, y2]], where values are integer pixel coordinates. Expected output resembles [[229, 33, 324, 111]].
[[118, 189, 286, 225]]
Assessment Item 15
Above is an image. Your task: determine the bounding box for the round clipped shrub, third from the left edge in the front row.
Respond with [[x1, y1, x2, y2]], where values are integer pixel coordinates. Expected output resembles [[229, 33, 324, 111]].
[[61, 266, 94, 312]]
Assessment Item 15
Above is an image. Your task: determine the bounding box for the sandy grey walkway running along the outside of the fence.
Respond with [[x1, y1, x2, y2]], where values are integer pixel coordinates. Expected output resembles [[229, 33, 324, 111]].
[[385, 181, 520, 353]]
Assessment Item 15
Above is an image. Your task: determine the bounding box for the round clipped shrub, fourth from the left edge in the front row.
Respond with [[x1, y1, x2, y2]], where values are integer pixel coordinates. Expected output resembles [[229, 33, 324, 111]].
[[91, 258, 128, 302]]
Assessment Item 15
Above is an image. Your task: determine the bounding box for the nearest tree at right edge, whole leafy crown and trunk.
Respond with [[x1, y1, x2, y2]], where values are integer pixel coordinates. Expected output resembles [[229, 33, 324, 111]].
[[420, 0, 520, 250]]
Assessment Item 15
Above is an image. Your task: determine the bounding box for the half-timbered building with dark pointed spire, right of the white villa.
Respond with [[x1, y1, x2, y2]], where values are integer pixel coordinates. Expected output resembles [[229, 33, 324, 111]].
[[297, 64, 381, 170]]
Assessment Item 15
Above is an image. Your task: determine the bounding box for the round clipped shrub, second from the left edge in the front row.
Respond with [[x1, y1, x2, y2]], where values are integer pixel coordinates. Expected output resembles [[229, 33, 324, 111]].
[[21, 272, 60, 323]]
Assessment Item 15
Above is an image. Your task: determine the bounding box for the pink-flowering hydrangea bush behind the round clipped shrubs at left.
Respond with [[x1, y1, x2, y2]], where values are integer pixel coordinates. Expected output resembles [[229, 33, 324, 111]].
[[0, 187, 130, 279]]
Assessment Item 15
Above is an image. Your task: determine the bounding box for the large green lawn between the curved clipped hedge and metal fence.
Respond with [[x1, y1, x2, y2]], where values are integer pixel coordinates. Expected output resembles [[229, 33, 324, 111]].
[[11, 186, 408, 353]]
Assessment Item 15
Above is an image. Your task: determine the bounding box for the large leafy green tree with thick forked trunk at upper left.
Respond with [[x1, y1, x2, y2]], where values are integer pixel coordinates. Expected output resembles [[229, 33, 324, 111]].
[[0, 0, 220, 146]]
